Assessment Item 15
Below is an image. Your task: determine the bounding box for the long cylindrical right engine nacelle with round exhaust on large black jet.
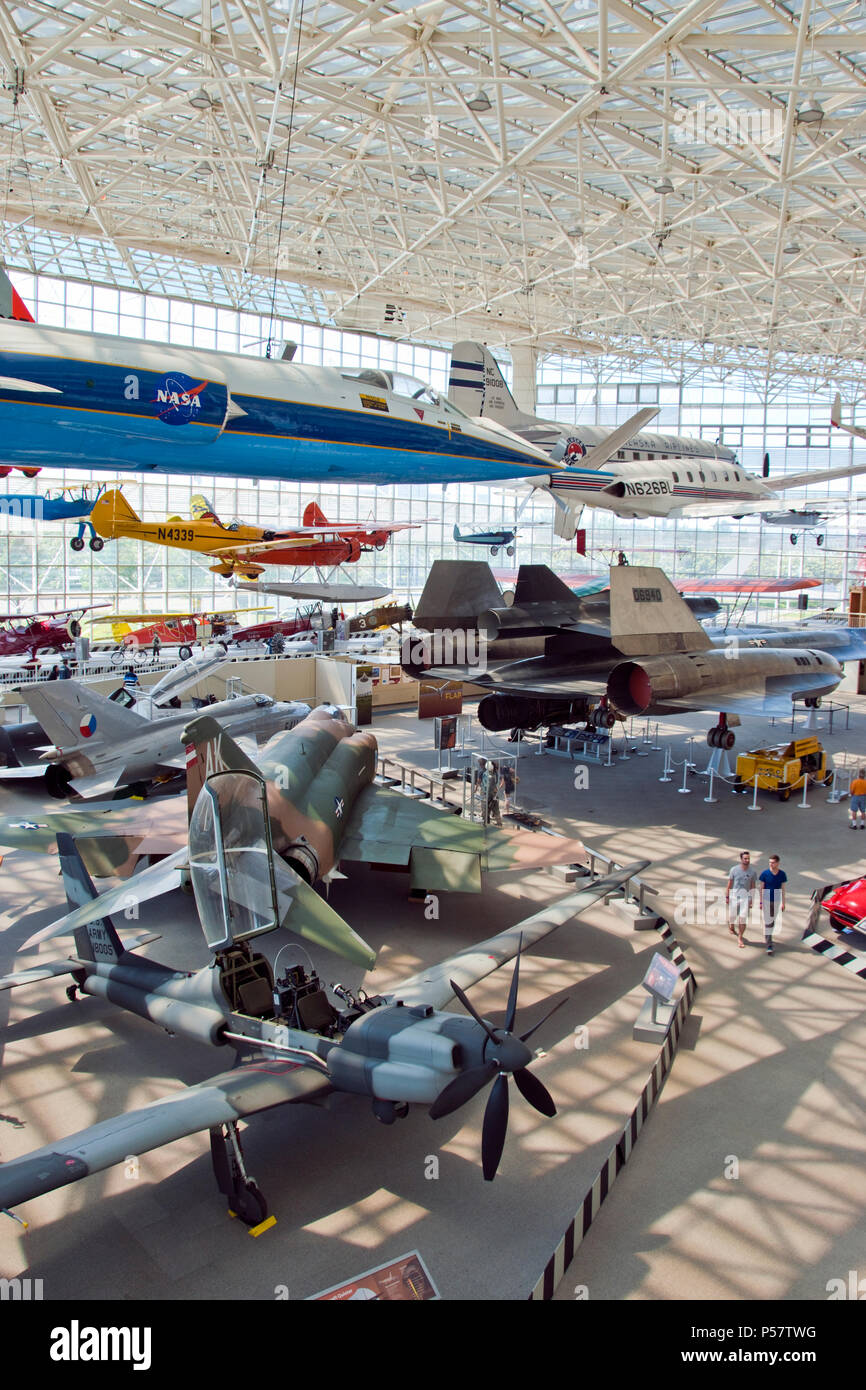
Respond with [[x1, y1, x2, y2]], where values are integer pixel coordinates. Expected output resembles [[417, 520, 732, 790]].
[[607, 645, 842, 714]]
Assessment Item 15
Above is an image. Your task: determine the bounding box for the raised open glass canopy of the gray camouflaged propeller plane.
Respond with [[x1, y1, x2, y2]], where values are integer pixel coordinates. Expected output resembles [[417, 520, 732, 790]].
[[189, 771, 279, 951]]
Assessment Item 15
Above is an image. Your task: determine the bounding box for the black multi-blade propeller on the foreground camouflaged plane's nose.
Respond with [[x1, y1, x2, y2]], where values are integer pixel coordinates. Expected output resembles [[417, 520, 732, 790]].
[[430, 948, 566, 1183]]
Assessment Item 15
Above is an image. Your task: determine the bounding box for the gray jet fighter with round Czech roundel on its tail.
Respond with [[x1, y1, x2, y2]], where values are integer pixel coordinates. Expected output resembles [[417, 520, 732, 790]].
[[0, 680, 310, 798]]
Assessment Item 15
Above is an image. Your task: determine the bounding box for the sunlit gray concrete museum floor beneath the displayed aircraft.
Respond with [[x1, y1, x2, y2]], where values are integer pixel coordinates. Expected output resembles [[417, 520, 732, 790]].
[[0, 698, 866, 1300]]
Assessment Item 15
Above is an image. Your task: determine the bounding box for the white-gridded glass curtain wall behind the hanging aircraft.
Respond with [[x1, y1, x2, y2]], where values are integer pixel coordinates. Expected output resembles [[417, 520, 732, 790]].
[[0, 272, 866, 628]]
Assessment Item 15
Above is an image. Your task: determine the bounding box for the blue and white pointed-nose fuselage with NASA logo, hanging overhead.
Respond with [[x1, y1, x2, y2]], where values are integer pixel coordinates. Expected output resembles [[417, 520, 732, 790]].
[[0, 320, 556, 484]]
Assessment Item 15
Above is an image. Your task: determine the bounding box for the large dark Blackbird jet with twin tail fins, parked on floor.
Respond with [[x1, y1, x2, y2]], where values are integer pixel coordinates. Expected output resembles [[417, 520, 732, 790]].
[[403, 560, 866, 749]]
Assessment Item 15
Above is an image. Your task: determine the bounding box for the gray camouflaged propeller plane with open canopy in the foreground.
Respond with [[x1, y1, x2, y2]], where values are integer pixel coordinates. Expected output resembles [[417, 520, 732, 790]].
[[0, 772, 646, 1227]]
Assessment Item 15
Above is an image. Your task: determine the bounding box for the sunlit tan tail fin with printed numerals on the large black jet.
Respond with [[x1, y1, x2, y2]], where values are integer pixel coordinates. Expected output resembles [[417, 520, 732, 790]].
[[610, 564, 712, 656]]
